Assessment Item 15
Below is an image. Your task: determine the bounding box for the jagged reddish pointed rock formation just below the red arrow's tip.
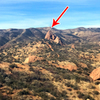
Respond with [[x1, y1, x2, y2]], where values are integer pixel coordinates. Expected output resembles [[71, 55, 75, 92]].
[[45, 30, 63, 45]]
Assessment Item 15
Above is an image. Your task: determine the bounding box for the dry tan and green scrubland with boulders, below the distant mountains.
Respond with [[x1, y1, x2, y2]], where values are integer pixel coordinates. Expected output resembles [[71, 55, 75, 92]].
[[0, 28, 100, 100]]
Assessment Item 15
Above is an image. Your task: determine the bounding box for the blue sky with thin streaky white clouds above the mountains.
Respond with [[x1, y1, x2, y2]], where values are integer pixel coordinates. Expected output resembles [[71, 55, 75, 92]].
[[0, 0, 100, 29]]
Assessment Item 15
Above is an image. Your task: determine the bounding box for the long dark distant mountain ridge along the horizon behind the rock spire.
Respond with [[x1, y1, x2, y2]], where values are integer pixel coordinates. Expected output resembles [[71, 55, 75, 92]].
[[0, 27, 100, 47]]
